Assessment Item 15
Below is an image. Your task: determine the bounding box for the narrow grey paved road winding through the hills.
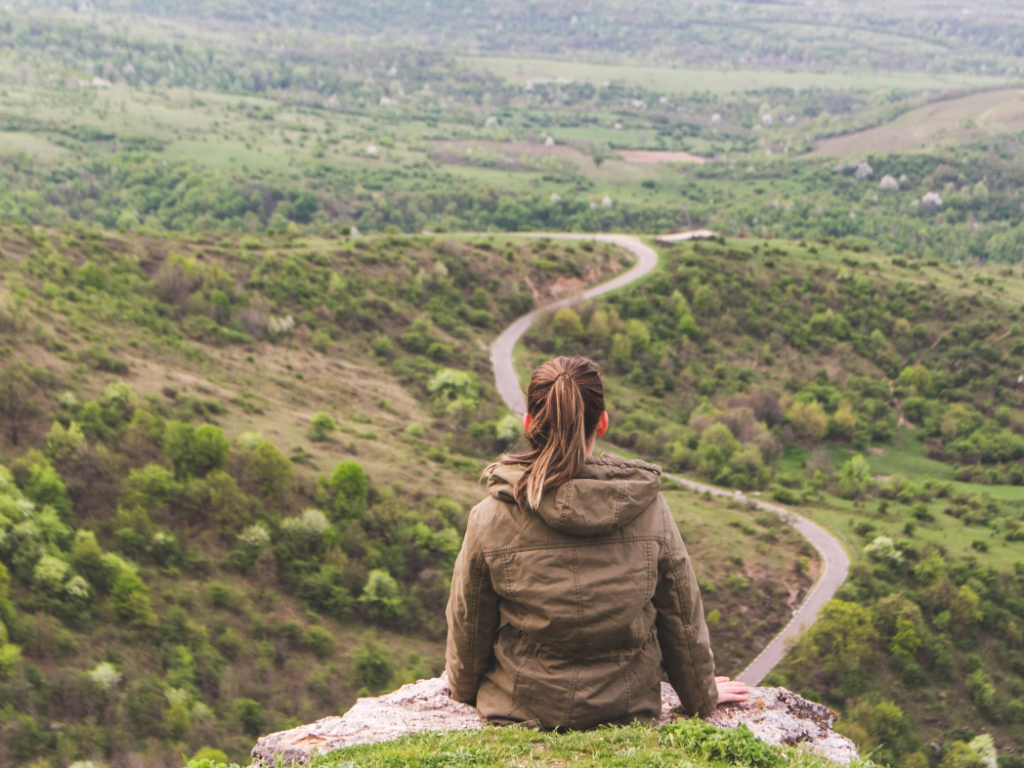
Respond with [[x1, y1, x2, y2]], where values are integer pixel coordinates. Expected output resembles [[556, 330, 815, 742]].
[[490, 233, 850, 685]]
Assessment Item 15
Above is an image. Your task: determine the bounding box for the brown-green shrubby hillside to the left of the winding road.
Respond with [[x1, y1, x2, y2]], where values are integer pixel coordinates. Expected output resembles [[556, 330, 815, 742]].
[[0, 226, 817, 766]]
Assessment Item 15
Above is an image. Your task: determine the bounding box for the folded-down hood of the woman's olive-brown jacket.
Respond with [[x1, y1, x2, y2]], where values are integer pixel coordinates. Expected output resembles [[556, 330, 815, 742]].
[[484, 454, 662, 536]]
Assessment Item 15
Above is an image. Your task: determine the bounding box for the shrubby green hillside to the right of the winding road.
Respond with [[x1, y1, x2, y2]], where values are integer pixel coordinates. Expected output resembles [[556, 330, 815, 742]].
[[520, 239, 1024, 765]]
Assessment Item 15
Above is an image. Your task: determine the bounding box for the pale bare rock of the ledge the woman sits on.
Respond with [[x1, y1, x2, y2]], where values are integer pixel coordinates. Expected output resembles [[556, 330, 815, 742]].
[[252, 677, 857, 768]]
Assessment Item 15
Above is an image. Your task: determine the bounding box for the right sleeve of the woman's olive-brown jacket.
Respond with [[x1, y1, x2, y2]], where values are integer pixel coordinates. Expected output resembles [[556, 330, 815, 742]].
[[653, 498, 718, 717]]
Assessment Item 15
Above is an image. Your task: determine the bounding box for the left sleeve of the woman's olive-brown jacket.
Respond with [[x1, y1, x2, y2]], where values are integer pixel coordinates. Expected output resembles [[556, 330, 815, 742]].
[[444, 509, 501, 703]]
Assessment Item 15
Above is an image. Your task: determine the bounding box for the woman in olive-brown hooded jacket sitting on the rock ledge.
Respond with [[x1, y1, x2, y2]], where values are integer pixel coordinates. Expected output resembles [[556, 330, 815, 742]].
[[447, 357, 746, 729]]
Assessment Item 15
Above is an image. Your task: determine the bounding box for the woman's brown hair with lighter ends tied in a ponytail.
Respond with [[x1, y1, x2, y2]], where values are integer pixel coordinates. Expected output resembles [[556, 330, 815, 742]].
[[499, 357, 604, 510]]
